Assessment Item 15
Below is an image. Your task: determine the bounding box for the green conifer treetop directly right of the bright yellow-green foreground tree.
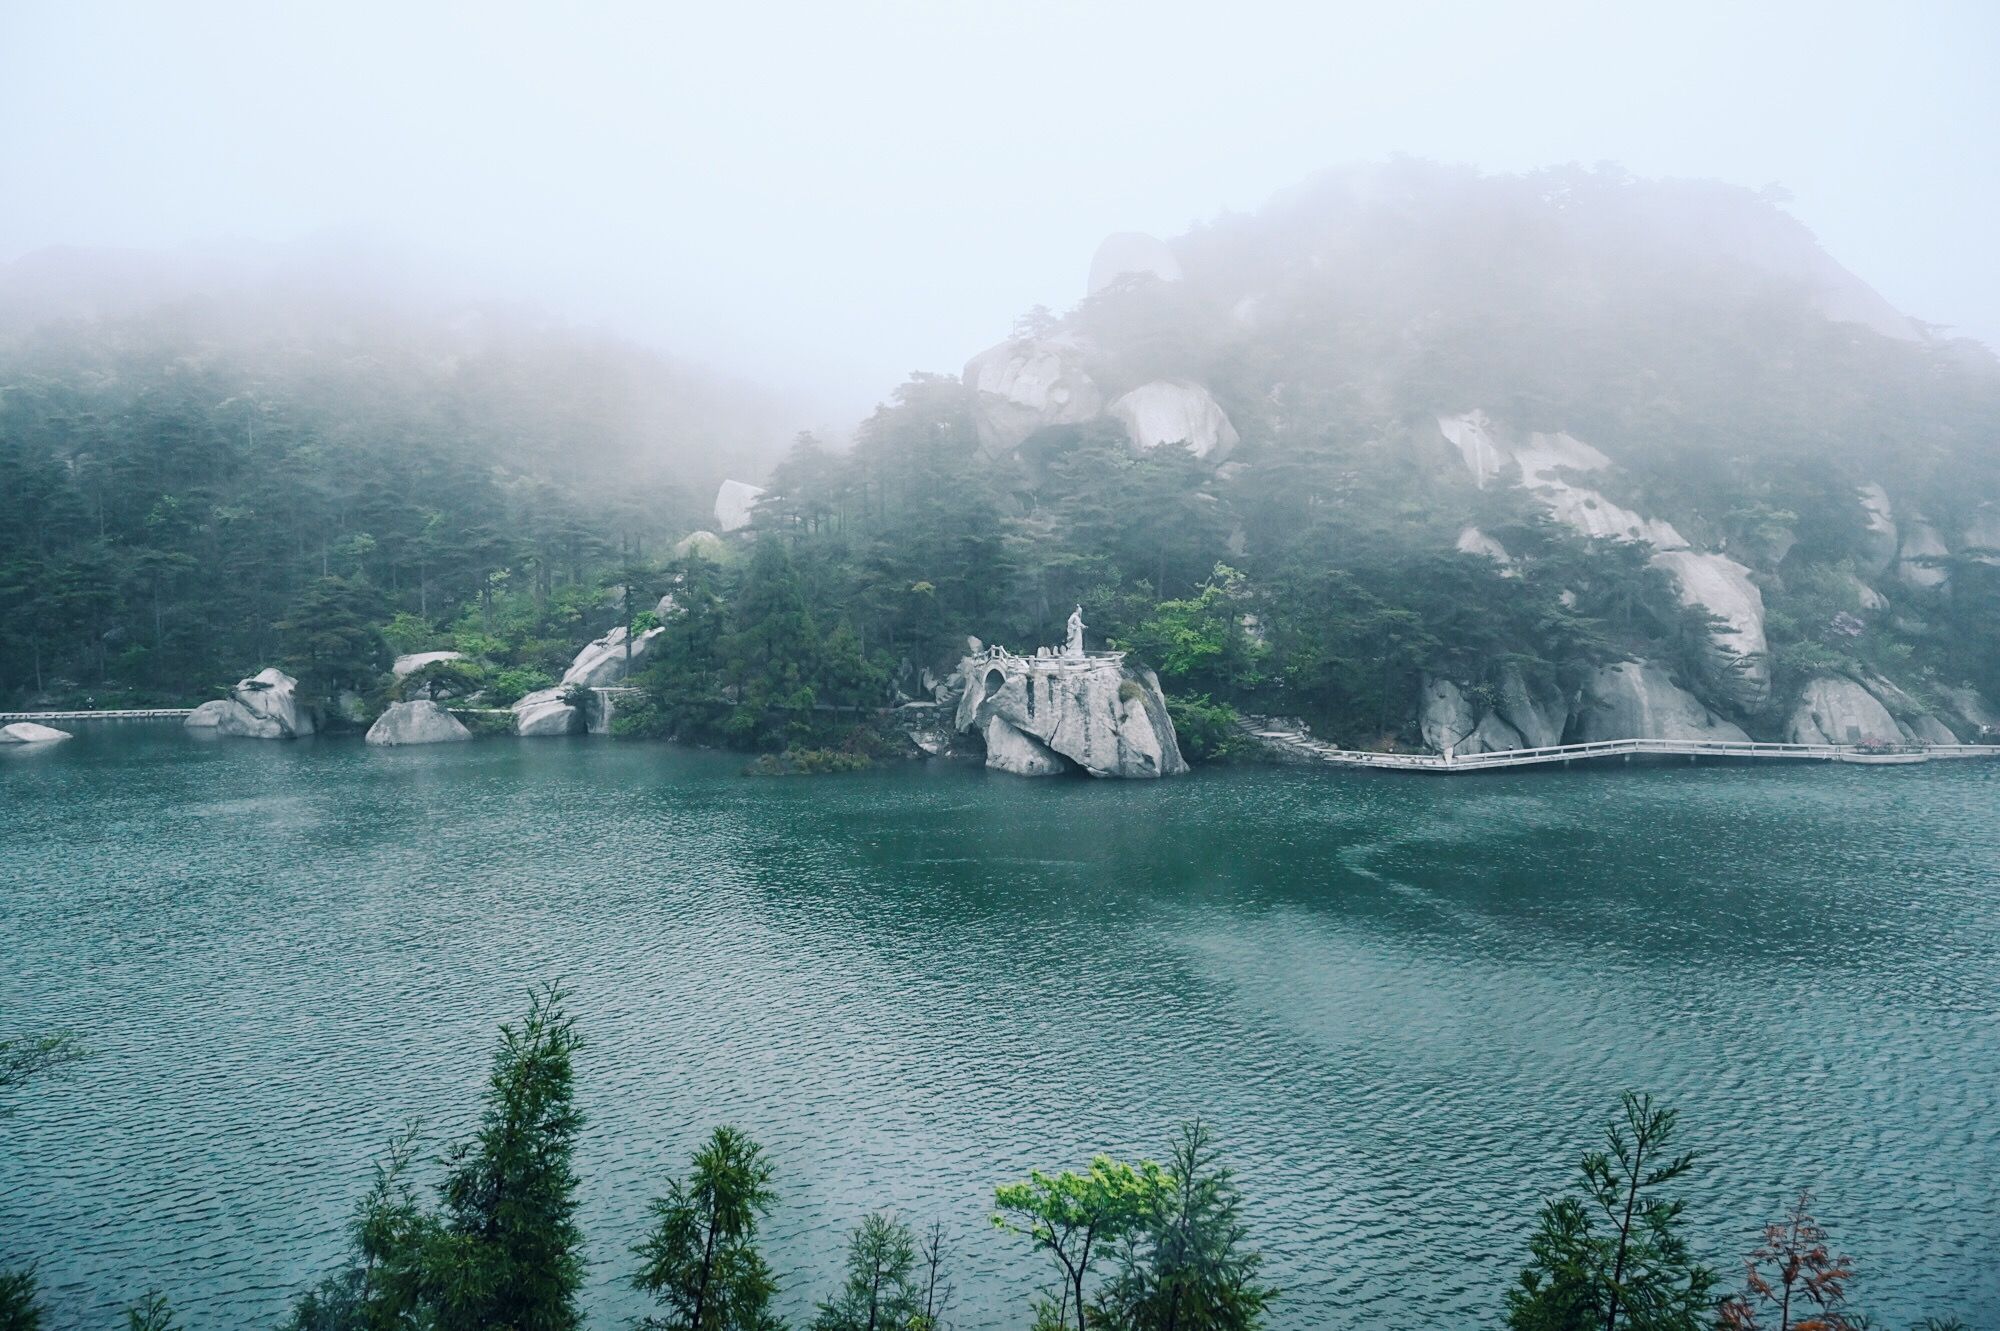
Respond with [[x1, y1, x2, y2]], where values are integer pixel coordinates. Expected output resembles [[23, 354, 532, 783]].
[[1092, 1121, 1278, 1331]]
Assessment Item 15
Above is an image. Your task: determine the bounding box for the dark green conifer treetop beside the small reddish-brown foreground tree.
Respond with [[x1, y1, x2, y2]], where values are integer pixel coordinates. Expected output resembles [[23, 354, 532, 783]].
[[1506, 1091, 1718, 1331]]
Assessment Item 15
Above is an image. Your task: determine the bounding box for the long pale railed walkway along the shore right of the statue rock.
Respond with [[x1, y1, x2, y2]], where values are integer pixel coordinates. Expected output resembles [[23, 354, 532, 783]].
[[1236, 715, 2000, 773]]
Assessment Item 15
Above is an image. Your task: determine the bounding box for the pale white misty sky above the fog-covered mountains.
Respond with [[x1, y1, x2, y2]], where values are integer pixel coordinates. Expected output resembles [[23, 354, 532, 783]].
[[0, 0, 2000, 412]]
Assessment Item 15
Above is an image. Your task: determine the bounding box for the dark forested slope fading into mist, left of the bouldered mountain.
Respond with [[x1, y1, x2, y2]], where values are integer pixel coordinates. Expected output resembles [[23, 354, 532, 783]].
[[0, 252, 786, 699]]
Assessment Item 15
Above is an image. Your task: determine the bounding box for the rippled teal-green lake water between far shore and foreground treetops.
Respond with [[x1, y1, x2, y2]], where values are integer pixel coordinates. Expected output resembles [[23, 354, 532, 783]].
[[0, 723, 2000, 1331]]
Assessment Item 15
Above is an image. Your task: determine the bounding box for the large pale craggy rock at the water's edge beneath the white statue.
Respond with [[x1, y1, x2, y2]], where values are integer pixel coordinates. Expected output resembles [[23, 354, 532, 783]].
[[956, 650, 1188, 777]]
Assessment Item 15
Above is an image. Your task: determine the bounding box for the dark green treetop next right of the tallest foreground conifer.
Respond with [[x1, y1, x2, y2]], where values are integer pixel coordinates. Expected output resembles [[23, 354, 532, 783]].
[[632, 1127, 778, 1331]]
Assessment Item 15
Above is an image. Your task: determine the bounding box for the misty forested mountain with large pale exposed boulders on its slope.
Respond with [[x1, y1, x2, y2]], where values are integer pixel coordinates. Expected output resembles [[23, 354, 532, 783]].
[[760, 162, 2000, 751]]
